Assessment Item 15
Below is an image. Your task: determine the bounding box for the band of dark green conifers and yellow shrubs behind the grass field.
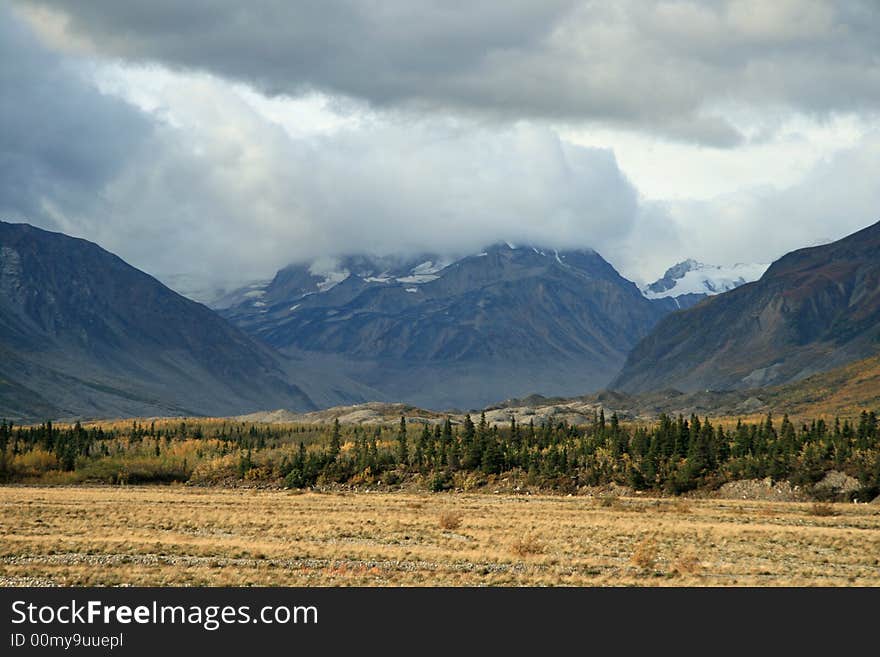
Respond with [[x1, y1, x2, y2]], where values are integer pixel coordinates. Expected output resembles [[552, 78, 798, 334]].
[[0, 410, 880, 500]]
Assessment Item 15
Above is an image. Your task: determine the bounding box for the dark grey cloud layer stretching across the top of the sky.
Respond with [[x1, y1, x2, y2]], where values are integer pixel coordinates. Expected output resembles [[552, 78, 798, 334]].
[[12, 0, 880, 147]]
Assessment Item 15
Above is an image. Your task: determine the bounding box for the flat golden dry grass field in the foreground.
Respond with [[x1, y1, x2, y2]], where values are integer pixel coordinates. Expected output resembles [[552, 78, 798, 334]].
[[0, 486, 880, 586]]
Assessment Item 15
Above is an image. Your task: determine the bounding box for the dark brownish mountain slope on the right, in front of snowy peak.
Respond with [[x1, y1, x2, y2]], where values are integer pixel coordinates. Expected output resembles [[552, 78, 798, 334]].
[[612, 223, 880, 392]]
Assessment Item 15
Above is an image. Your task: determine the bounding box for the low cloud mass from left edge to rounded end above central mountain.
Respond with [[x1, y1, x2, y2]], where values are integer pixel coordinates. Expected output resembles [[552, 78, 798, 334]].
[[0, 4, 639, 282]]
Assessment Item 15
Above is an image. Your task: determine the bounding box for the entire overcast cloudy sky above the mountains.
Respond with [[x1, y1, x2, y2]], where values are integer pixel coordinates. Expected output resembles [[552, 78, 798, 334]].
[[0, 0, 880, 284]]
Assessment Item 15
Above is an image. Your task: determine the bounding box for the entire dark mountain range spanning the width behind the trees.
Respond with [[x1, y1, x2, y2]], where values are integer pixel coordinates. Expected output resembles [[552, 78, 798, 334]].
[[6, 221, 880, 418]]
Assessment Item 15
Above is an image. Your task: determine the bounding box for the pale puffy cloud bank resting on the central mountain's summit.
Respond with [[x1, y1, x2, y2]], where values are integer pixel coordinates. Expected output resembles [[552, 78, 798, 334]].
[[94, 80, 639, 278]]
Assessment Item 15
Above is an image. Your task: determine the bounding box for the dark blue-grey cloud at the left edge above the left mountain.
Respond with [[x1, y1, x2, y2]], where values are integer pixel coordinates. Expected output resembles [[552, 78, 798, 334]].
[[0, 6, 152, 227]]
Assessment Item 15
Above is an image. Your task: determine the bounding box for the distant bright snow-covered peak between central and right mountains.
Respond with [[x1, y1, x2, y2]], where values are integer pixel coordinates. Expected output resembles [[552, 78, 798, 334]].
[[642, 259, 767, 309]]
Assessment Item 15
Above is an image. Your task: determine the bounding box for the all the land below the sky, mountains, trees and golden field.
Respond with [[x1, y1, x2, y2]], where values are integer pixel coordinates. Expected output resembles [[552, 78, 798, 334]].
[[0, 224, 880, 586]]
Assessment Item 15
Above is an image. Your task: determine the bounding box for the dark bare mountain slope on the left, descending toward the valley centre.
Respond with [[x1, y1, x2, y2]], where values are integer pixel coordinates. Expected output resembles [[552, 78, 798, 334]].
[[0, 222, 374, 419]]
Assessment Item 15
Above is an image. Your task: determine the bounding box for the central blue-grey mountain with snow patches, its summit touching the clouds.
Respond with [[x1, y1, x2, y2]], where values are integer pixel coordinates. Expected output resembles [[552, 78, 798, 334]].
[[220, 243, 674, 408]]
